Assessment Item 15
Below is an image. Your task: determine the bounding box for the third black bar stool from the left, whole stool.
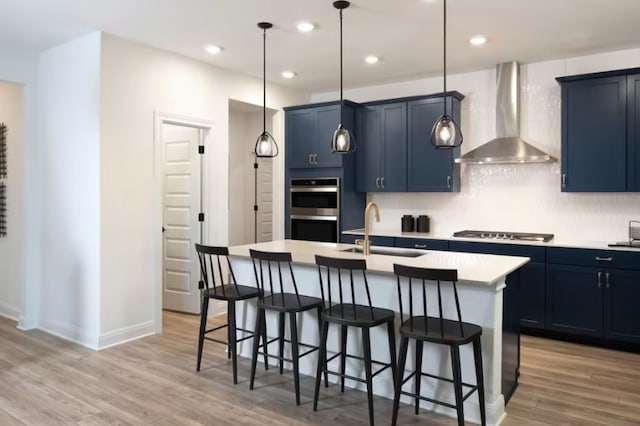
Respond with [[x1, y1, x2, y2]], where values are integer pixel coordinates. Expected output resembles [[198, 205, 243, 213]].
[[313, 256, 396, 425]]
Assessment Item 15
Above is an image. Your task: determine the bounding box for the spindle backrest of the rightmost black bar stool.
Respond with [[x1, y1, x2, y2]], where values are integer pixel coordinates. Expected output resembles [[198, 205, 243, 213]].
[[393, 264, 464, 336]]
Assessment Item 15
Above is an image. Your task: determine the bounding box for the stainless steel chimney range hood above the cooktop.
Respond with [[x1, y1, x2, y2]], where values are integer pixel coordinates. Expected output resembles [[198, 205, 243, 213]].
[[455, 62, 557, 164]]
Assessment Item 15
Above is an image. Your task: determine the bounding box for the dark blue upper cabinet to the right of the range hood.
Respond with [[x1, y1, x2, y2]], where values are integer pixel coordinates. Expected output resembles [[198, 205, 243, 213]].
[[557, 69, 640, 192]]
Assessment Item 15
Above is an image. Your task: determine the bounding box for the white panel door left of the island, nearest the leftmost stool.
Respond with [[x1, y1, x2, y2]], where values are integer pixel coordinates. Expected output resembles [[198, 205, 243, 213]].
[[162, 124, 201, 313]]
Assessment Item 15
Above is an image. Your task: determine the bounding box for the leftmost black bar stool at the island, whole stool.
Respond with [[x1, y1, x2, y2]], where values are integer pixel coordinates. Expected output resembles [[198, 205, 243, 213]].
[[196, 243, 267, 384]]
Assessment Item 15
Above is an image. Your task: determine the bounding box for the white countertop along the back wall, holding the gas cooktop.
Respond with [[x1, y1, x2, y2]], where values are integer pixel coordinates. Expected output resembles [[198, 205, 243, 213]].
[[342, 228, 640, 253]]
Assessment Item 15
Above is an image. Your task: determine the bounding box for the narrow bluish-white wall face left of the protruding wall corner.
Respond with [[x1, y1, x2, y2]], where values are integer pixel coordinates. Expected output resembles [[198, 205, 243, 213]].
[[38, 33, 101, 348]]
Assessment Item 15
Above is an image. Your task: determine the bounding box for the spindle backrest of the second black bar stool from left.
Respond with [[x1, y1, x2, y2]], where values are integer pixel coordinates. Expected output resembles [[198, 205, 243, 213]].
[[249, 249, 301, 306]]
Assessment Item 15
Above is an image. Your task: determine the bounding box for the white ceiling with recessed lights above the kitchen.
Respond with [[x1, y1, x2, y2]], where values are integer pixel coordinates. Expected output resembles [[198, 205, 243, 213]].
[[0, 0, 640, 92]]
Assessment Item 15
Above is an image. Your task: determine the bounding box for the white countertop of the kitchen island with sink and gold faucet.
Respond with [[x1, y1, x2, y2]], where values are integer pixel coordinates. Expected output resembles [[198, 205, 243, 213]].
[[229, 240, 529, 284]]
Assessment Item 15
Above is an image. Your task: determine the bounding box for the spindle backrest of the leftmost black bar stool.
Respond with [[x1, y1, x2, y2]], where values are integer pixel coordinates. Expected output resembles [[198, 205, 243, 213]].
[[196, 243, 238, 297]]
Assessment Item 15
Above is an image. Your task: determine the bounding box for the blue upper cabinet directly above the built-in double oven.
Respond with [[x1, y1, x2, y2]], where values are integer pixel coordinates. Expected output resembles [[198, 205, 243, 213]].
[[285, 101, 357, 168]]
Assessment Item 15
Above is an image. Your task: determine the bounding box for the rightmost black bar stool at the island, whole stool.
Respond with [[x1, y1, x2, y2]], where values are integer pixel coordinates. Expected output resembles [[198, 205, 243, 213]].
[[391, 264, 486, 426]]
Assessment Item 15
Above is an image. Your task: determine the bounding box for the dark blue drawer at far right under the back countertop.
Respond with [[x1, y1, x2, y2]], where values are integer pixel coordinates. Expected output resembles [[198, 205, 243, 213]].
[[547, 247, 640, 269]]
